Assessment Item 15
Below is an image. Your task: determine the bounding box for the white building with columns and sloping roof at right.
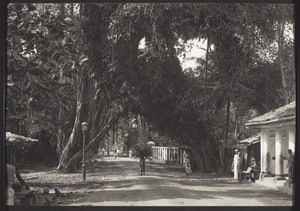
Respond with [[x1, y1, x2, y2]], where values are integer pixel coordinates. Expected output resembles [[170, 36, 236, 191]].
[[246, 101, 296, 180]]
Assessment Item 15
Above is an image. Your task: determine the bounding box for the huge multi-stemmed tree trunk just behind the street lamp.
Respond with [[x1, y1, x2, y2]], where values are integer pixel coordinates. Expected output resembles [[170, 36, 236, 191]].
[[58, 71, 123, 172]]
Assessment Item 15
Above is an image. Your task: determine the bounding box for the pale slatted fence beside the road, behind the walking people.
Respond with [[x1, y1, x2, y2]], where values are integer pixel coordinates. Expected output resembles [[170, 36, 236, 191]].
[[152, 146, 187, 164]]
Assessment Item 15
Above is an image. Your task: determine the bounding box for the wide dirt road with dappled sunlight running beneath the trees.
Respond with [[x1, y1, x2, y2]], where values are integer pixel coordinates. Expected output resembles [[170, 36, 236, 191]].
[[48, 157, 292, 206]]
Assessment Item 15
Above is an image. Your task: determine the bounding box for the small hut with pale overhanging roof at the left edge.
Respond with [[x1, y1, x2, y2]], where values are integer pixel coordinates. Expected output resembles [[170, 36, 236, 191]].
[[6, 132, 38, 166]]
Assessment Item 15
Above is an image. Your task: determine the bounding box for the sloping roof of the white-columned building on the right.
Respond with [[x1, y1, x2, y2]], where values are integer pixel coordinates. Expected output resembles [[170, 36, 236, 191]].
[[246, 101, 296, 126]]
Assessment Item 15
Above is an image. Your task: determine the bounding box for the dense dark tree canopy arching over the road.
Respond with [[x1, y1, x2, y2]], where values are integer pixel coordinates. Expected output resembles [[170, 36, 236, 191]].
[[7, 4, 295, 171]]
